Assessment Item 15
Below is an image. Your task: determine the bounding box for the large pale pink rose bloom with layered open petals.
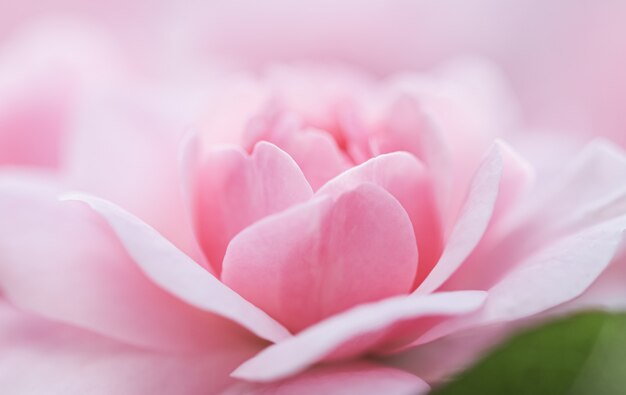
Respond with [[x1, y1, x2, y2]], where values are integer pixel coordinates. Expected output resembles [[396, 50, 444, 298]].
[[0, 27, 626, 394]]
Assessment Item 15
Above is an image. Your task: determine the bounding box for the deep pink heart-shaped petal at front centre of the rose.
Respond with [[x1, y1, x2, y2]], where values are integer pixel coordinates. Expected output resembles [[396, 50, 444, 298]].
[[222, 184, 417, 331]]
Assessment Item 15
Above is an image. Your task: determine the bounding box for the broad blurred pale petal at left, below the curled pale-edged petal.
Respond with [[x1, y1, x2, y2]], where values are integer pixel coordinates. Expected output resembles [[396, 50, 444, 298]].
[[0, 178, 244, 351]]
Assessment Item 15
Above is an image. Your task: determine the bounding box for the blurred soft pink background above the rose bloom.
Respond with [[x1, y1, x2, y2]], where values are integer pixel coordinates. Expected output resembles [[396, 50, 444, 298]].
[[0, 0, 626, 145]]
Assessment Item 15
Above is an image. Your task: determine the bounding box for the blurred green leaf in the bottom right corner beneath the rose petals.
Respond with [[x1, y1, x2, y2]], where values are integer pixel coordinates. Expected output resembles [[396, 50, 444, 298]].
[[431, 312, 626, 395]]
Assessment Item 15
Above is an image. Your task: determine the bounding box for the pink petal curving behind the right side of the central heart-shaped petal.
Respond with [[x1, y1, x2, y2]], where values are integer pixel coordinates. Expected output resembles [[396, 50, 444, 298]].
[[317, 152, 443, 288]]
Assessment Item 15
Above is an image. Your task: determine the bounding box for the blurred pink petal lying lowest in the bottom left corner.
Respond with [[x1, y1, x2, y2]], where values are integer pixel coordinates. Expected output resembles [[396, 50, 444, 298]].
[[0, 302, 256, 395]]
